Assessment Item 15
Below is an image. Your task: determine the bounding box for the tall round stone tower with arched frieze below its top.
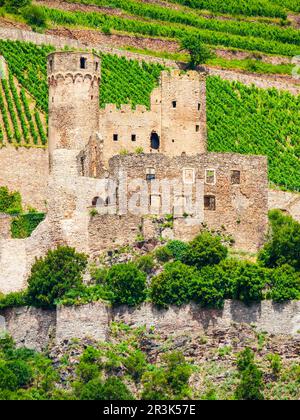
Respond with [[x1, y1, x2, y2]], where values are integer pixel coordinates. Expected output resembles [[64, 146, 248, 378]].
[[48, 51, 101, 166]]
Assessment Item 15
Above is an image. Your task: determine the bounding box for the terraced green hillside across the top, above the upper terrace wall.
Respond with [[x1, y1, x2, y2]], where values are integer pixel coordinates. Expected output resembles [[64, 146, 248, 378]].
[[34, 0, 300, 57]]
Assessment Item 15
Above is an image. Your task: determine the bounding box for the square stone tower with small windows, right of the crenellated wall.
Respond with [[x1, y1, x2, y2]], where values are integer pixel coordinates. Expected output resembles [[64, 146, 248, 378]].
[[160, 70, 207, 156]]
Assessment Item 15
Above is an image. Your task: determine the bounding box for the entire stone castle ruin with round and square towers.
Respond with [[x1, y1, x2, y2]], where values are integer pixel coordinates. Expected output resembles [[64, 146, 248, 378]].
[[0, 52, 268, 293]]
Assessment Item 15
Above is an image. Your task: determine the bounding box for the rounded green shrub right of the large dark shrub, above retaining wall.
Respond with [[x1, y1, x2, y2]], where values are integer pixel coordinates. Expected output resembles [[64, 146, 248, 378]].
[[106, 263, 146, 306]]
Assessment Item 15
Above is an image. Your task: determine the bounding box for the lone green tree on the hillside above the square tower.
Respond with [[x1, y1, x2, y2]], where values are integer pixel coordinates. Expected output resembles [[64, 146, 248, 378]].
[[180, 34, 214, 69]]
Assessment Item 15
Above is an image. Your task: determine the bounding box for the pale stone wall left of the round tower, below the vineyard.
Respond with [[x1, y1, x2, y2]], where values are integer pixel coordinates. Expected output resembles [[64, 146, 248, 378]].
[[0, 146, 49, 211]]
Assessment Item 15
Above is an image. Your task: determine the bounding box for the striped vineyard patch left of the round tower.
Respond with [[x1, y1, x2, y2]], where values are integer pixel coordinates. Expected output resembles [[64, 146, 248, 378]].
[[0, 41, 47, 146]]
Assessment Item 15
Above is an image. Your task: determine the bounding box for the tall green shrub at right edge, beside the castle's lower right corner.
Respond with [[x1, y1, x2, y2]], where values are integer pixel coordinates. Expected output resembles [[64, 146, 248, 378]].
[[258, 210, 300, 270]]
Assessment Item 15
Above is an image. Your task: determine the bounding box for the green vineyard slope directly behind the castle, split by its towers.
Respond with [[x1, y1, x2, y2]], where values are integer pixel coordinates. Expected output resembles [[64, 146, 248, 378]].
[[0, 41, 300, 191]]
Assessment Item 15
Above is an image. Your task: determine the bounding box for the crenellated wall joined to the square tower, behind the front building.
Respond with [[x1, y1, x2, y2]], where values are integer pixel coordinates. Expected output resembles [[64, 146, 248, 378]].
[[100, 70, 207, 164]]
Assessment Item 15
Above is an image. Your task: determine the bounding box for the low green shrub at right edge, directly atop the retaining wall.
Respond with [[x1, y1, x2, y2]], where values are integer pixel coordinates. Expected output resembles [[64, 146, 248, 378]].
[[267, 265, 300, 302]]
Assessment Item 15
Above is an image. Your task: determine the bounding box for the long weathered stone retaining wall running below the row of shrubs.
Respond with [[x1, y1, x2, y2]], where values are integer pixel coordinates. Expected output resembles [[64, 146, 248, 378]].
[[0, 300, 300, 351]]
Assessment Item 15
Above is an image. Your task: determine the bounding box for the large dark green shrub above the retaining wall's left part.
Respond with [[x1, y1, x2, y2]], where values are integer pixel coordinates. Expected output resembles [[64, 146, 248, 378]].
[[28, 247, 87, 307]]
